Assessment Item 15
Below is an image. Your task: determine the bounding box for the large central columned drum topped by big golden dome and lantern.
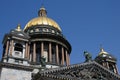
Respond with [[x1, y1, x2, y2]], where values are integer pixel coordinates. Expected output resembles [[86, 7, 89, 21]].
[[24, 7, 71, 67]]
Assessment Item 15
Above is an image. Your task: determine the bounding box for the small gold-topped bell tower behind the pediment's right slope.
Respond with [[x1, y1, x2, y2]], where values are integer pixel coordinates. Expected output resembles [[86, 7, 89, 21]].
[[95, 48, 118, 74]]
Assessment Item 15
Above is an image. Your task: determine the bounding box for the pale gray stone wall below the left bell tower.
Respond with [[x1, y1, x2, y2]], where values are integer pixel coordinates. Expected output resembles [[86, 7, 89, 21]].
[[0, 68, 31, 80]]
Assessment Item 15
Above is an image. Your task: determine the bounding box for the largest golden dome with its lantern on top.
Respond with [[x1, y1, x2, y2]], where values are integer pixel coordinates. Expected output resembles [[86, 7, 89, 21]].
[[24, 7, 61, 31]]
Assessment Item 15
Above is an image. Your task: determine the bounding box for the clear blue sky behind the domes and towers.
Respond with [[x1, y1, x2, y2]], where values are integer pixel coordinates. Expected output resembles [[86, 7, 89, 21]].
[[0, 0, 120, 71]]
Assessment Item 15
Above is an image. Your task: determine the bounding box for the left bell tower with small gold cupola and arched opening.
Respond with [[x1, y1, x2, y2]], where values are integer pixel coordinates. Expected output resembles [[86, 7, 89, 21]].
[[2, 24, 29, 64]]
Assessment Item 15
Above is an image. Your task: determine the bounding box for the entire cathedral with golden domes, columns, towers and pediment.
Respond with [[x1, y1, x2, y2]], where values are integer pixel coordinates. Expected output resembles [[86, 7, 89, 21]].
[[0, 7, 120, 80]]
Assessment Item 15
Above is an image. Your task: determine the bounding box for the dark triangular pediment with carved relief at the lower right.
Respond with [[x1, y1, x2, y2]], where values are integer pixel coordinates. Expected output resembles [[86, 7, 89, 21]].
[[33, 61, 120, 80]]
